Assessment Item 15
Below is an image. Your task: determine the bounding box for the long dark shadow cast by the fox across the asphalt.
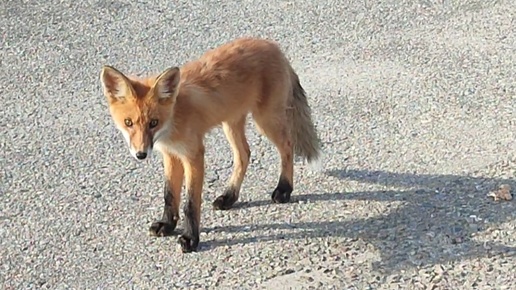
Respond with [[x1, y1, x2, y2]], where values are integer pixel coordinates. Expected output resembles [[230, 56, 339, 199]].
[[203, 170, 516, 273]]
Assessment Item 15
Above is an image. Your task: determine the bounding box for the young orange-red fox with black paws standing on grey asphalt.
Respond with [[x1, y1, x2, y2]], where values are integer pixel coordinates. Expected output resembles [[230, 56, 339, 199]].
[[100, 37, 321, 253]]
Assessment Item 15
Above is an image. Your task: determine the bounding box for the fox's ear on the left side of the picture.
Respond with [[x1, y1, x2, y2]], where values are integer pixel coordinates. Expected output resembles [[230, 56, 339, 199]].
[[100, 65, 131, 101]]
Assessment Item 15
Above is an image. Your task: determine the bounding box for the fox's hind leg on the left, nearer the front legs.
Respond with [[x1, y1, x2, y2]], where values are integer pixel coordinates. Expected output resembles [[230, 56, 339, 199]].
[[213, 116, 251, 210]]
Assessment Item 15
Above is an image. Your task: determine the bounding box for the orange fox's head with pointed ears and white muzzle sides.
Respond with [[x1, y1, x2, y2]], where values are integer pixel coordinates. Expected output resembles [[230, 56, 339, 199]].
[[100, 66, 180, 160]]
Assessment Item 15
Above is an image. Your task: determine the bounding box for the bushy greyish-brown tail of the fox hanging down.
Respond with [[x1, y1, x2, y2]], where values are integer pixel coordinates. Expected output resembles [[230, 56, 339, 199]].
[[291, 69, 321, 168]]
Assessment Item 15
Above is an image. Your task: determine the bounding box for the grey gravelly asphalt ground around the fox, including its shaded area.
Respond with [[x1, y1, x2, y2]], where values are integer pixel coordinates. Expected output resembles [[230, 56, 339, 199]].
[[0, 0, 516, 289]]
